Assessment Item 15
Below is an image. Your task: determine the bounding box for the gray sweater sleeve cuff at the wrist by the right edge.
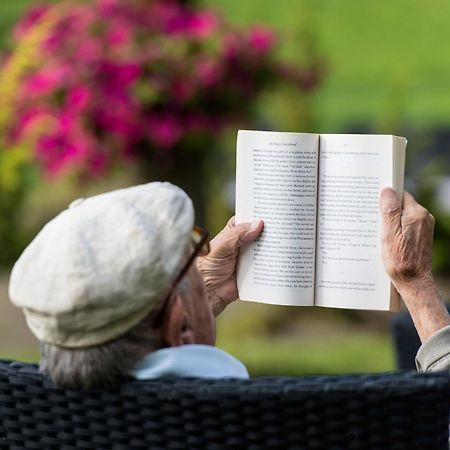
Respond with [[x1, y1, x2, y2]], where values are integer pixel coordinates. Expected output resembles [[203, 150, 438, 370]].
[[416, 326, 450, 372]]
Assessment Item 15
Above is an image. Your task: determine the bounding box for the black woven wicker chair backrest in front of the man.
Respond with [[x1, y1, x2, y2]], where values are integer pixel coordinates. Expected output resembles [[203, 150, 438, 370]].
[[0, 361, 450, 450]]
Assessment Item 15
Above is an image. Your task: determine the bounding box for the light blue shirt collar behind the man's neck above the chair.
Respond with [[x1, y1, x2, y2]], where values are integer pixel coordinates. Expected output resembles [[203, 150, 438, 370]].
[[130, 344, 249, 380]]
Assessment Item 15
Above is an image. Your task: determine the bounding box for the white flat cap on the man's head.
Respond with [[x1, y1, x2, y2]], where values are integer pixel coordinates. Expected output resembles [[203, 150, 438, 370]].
[[9, 182, 194, 348]]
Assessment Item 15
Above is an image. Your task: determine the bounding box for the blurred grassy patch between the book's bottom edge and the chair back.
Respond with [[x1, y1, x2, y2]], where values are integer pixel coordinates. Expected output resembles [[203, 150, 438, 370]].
[[217, 302, 395, 375]]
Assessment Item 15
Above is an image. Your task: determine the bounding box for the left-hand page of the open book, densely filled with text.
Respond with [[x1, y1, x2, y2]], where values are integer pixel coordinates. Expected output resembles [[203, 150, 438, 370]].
[[236, 130, 318, 305]]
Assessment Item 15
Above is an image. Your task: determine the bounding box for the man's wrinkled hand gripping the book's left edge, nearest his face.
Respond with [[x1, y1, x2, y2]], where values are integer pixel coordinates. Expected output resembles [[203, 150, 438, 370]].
[[197, 217, 264, 316]]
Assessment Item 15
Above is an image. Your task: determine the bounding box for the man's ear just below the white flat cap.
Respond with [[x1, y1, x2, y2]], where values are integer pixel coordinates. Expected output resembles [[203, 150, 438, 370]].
[[162, 294, 194, 347]]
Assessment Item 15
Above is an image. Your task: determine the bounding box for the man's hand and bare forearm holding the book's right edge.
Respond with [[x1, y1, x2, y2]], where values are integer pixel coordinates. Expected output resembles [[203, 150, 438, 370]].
[[380, 188, 450, 342]]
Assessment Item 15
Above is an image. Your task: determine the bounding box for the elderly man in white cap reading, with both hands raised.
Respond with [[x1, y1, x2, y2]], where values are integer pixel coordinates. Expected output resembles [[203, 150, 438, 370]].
[[6, 183, 450, 388]]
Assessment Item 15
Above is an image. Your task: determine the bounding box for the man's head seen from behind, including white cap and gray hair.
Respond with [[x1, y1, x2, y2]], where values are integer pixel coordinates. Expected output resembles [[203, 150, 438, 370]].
[[10, 183, 214, 387]]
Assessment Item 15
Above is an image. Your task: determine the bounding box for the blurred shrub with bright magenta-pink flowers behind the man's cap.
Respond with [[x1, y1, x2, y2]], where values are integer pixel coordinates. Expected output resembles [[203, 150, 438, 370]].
[[4, 0, 320, 176]]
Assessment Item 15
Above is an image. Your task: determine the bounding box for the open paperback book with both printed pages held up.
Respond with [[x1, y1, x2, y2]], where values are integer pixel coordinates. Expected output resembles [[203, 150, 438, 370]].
[[236, 130, 406, 310]]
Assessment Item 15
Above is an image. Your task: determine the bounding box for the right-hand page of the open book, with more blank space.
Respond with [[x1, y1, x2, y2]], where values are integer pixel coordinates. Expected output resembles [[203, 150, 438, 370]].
[[315, 135, 406, 310]]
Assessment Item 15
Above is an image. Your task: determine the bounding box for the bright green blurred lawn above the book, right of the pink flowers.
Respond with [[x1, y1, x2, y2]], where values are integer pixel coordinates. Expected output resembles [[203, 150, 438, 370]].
[[206, 0, 450, 133]]
